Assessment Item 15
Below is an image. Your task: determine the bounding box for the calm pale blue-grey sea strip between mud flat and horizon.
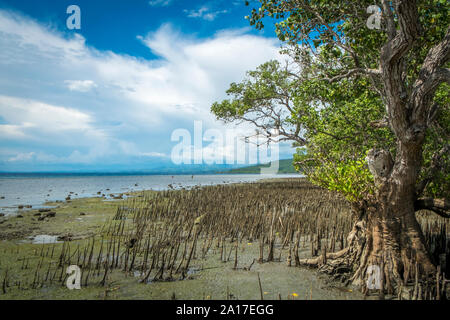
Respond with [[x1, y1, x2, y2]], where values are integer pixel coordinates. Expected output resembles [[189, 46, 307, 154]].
[[0, 174, 300, 215]]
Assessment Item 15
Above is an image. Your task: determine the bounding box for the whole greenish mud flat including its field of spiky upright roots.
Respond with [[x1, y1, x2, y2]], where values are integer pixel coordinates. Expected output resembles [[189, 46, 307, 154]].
[[0, 179, 444, 300]]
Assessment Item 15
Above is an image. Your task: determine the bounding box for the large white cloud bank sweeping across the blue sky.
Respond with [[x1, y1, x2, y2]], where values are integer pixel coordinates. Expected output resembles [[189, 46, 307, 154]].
[[0, 8, 290, 170]]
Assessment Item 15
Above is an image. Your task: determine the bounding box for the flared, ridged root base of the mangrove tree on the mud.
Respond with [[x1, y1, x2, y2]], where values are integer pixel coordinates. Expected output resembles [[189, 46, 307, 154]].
[[299, 216, 442, 299]]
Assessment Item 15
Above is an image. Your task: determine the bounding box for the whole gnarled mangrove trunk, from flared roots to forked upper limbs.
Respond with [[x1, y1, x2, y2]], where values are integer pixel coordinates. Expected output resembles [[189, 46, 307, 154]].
[[301, 0, 450, 298]]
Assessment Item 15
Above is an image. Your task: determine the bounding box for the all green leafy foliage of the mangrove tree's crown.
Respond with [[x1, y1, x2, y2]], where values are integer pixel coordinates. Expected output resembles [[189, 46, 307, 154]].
[[212, 0, 450, 201]]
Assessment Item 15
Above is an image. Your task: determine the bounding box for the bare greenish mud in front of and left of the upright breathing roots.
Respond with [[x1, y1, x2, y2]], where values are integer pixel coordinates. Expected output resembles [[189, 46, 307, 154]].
[[0, 181, 384, 300]]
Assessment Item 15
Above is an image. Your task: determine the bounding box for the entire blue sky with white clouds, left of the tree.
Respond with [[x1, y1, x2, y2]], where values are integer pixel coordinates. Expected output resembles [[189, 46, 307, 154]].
[[0, 0, 294, 172]]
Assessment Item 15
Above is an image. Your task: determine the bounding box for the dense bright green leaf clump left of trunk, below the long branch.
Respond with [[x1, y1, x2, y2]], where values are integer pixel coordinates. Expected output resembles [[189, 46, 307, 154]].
[[295, 74, 394, 201]]
